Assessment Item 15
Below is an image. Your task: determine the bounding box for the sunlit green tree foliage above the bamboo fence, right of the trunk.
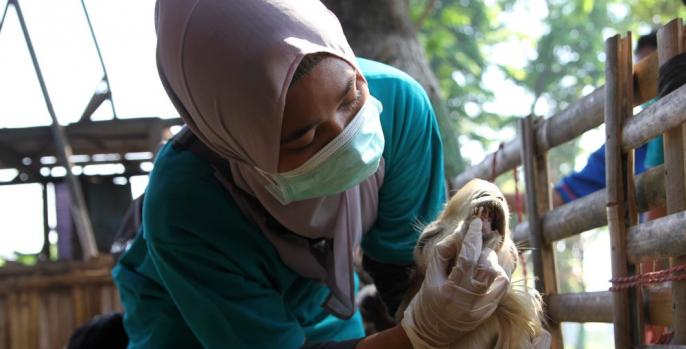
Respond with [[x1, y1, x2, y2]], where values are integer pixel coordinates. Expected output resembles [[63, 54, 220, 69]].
[[409, 0, 686, 179]]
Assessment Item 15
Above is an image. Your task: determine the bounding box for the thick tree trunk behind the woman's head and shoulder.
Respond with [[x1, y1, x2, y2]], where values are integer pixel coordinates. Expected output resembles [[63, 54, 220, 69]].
[[323, 0, 464, 178]]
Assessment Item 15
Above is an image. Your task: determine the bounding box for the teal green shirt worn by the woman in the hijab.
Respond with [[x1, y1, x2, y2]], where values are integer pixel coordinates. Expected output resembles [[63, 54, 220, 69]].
[[113, 59, 445, 349]]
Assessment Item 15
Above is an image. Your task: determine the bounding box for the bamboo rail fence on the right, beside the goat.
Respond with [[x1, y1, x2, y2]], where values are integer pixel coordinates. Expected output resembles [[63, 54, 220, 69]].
[[450, 19, 686, 348]]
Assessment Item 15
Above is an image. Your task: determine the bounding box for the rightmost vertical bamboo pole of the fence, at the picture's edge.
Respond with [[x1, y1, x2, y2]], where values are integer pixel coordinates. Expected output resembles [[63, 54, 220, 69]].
[[657, 18, 686, 344]]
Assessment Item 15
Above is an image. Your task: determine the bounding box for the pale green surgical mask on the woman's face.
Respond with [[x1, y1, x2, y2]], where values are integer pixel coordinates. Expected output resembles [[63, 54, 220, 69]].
[[261, 96, 384, 205]]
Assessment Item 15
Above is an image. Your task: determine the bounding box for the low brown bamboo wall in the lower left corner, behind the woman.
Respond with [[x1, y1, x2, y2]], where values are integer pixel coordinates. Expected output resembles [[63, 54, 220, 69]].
[[0, 256, 123, 349]]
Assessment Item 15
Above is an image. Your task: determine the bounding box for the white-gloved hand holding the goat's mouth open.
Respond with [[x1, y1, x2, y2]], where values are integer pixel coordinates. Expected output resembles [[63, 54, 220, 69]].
[[401, 218, 510, 349]]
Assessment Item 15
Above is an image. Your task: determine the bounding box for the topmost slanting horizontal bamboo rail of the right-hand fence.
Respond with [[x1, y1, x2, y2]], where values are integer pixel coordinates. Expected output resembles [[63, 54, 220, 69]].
[[450, 53, 658, 189]]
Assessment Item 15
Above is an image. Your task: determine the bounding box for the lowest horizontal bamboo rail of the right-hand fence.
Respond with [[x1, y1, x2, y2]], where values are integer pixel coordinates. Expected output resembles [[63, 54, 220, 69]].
[[545, 288, 672, 326]]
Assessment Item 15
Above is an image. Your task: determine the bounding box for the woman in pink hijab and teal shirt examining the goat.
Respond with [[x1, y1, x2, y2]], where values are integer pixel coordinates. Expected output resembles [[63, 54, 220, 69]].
[[113, 0, 509, 349]]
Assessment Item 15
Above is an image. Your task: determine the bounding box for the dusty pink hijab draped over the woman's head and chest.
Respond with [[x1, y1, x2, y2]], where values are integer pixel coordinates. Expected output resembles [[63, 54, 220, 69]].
[[157, 0, 384, 318]]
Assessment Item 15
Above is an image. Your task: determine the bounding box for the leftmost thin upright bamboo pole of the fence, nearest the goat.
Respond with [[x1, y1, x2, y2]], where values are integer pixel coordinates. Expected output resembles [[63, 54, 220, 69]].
[[519, 115, 563, 349]]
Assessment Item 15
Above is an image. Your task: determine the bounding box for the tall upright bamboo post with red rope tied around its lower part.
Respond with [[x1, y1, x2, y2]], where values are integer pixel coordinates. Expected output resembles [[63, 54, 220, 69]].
[[605, 33, 642, 348]]
